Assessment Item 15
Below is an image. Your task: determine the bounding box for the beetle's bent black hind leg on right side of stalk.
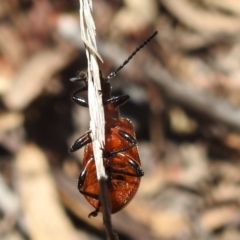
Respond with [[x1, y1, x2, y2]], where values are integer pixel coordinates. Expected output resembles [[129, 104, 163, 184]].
[[107, 158, 144, 177]]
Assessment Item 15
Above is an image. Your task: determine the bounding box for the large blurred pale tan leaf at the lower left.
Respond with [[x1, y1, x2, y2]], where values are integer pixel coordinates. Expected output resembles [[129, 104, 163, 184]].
[[16, 144, 78, 240]]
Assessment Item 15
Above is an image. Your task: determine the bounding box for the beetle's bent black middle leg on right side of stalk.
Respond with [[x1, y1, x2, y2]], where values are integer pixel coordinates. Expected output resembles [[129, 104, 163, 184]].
[[103, 130, 137, 158]]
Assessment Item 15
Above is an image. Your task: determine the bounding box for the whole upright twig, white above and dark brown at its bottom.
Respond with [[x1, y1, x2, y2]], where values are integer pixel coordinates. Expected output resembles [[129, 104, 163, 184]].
[[80, 0, 118, 240]]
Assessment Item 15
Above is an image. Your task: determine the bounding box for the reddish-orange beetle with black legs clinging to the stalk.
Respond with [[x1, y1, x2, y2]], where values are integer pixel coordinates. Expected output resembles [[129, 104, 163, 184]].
[[69, 32, 157, 217]]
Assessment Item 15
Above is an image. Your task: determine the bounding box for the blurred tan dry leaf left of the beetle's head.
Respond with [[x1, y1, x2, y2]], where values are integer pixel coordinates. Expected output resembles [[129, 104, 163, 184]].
[[3, 48, 75, 110]]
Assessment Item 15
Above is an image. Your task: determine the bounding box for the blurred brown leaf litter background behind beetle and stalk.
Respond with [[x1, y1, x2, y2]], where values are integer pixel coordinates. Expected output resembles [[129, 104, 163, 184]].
[[0, 0, 240, 240]]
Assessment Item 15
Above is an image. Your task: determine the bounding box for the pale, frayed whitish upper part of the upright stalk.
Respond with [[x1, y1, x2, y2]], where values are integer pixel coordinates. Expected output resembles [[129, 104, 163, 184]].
[[79, 0, 106, 180]]
